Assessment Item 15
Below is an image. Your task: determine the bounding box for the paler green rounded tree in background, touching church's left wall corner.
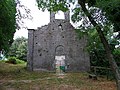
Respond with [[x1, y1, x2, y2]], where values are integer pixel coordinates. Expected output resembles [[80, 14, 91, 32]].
[[7, 37, 27, 61]]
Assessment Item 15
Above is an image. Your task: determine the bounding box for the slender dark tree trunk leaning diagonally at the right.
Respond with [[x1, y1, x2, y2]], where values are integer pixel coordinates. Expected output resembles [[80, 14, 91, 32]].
[[78, 0, 120, 90]]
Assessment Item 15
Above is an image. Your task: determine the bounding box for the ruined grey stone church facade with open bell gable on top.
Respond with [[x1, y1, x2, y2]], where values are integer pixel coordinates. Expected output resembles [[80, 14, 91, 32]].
[[27, 12, 90, 71]]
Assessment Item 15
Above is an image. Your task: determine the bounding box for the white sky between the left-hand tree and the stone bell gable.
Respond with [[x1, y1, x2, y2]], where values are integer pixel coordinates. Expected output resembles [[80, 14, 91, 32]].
[[14, 0, 50, 39]]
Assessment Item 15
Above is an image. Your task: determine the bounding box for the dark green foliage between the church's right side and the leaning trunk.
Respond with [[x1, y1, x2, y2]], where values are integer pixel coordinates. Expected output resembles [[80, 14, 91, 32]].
[[87, 28, 109, 67]]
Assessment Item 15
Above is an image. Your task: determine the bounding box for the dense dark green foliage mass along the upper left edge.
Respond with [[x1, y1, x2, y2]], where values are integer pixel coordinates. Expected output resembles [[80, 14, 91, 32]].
[[0, 0, 16, 51]]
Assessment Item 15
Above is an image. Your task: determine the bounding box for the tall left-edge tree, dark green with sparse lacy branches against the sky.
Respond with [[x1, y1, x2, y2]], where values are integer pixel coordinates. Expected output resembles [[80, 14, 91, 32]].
[[0, 0, 32, 52]]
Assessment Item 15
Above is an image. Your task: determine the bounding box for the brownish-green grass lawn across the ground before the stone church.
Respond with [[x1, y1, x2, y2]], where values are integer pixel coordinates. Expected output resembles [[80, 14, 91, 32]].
[[0, 62, 116, 90]]
